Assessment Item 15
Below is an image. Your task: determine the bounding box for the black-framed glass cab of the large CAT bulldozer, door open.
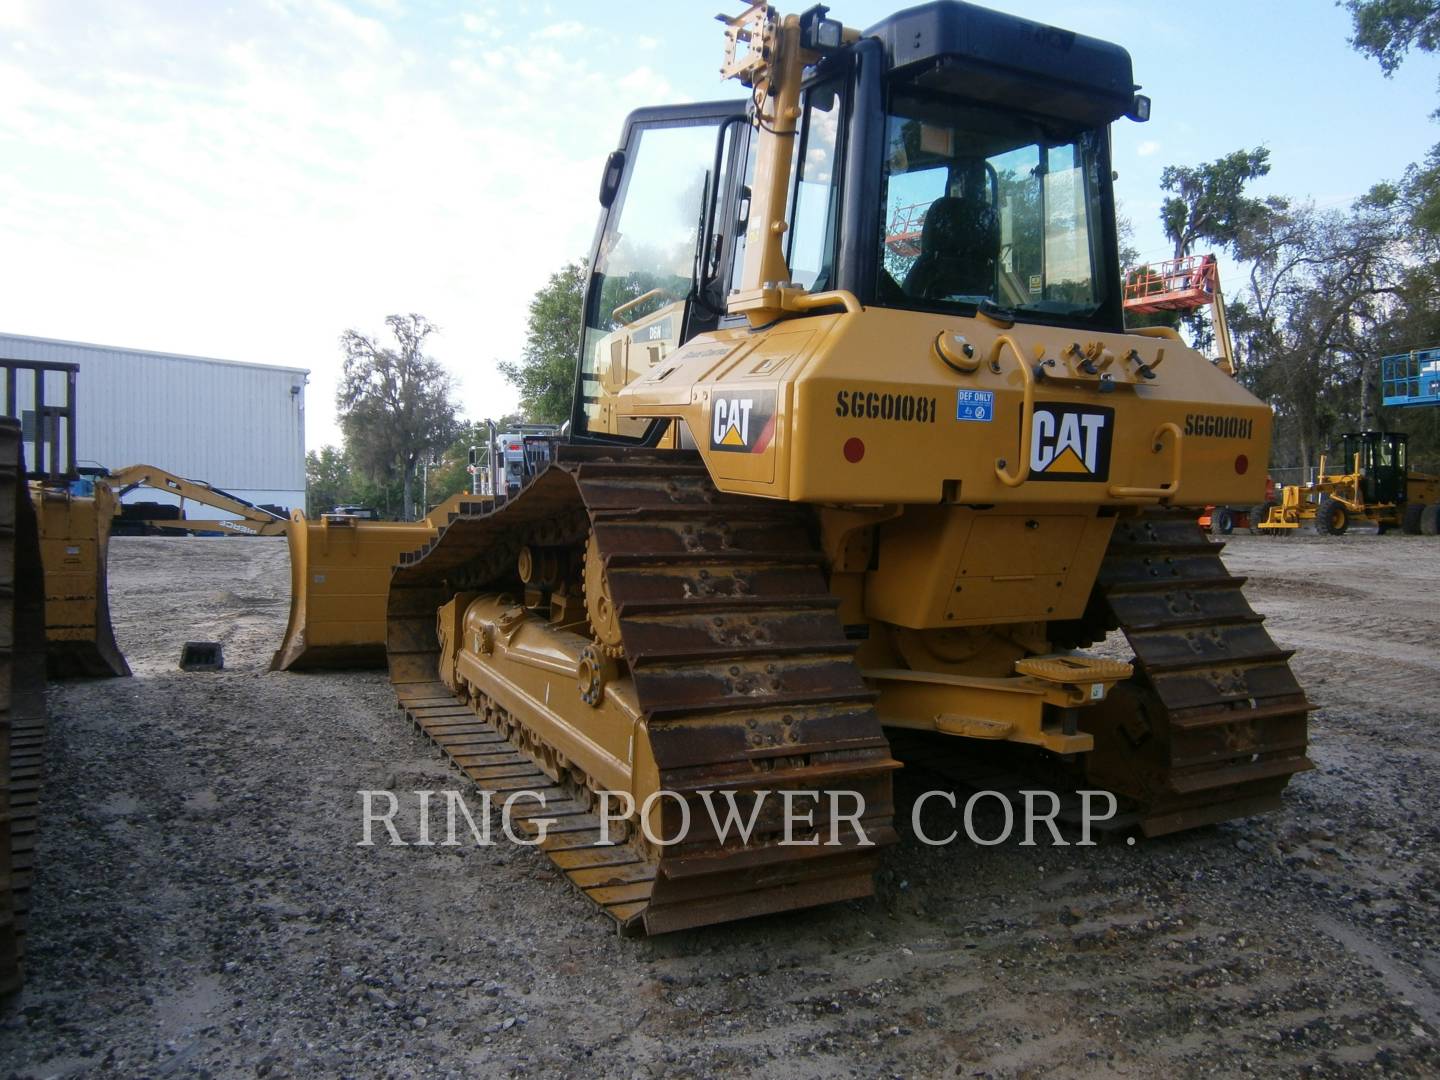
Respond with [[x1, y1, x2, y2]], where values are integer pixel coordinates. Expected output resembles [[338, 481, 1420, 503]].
[[572, 1, 1149, 445]]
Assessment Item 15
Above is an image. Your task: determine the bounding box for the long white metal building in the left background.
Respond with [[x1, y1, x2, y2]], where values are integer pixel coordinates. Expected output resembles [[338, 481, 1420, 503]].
[[0, 333, 310, 517]]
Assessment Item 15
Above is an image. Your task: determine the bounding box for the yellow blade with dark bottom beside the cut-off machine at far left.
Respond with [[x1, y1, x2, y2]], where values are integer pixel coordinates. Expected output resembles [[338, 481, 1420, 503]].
[[30, 481, 130, 678]]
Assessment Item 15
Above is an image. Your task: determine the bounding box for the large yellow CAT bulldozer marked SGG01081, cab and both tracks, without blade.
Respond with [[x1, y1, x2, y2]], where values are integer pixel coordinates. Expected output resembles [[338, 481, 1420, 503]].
[[387, 1, 1309, 933]]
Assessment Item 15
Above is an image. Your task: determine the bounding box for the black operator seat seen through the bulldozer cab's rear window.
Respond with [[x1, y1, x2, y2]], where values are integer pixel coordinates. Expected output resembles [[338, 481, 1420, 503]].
[[904, 194, 999, 300]]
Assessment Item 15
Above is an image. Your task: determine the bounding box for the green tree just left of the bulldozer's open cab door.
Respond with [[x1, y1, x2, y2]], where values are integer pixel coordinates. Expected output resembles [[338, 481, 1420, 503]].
[[500, 259, 586, 423]]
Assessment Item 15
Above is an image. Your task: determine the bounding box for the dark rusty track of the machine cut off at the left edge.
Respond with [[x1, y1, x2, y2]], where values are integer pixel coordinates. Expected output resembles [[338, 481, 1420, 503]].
[[0, 418, 45, 994]]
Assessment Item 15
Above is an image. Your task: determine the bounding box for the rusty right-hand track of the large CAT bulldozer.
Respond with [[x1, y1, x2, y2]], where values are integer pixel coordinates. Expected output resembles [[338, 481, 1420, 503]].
[[1080, 510, 1312, 835]]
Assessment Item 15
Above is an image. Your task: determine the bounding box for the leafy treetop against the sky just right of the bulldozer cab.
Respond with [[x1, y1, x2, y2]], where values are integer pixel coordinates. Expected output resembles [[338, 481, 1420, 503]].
[[1161, 147, 1280, 259]]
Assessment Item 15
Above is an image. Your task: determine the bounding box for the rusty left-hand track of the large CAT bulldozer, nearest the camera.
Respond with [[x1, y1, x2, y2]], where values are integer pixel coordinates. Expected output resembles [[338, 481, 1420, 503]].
[[389, 448, 897, 933]]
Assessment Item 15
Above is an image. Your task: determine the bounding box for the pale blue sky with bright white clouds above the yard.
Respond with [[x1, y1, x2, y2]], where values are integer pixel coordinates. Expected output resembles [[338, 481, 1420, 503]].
[[0, 0, 1440, 448]]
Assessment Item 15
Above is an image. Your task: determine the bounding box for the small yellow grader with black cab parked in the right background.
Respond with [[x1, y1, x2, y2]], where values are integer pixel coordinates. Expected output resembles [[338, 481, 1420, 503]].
[[1257, 431, 1440, 536]]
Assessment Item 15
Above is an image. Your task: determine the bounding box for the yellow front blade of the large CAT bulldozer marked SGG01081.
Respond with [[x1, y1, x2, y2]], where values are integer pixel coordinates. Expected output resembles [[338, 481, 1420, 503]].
[[271, 495, 488, 671]]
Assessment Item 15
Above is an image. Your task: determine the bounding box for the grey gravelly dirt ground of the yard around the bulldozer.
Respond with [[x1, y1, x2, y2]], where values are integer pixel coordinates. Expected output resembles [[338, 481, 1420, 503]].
[[0, 534, 1440, 1077]]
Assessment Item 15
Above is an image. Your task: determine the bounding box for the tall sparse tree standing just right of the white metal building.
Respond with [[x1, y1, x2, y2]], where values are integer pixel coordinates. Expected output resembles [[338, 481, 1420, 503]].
[[336, 314, 455, 520]]
